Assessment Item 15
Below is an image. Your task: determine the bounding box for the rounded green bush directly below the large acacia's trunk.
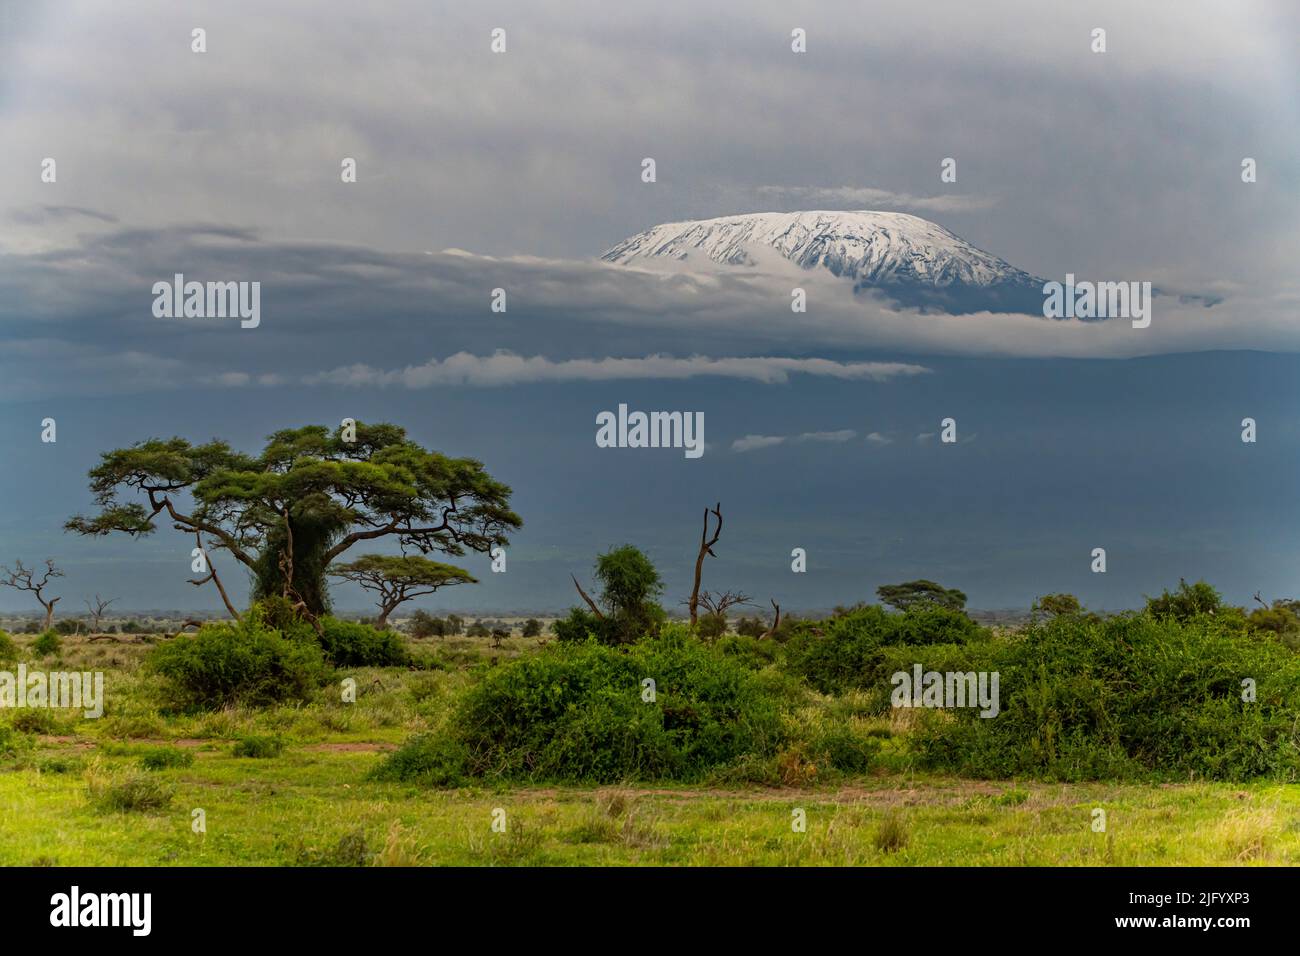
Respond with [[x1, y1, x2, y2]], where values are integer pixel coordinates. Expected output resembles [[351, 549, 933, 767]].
[[146, 606, 329, 710]]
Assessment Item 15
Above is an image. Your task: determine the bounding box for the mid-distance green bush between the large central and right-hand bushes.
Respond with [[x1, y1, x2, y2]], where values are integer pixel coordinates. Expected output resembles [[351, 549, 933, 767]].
[[783, 605, 989, 693]]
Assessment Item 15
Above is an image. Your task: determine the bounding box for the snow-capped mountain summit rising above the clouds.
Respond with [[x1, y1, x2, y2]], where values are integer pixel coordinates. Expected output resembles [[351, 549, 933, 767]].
[[601, 211, 1043, 312]]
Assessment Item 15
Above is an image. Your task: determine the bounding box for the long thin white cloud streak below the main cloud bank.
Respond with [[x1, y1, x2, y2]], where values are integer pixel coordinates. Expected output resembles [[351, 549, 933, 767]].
[[299, 351, 930, 387]]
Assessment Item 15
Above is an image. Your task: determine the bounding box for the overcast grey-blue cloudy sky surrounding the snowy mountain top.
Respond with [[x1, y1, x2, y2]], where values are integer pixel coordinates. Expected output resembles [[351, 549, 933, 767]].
[[0, 0, 1300, 610]]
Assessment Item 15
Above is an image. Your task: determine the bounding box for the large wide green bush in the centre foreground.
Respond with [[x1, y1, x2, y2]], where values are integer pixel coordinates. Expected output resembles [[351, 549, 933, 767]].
[[377, 627, 784, 786]]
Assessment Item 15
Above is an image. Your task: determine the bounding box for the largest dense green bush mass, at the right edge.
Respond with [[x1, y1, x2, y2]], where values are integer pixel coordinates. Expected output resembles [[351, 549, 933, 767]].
[[913, 614, 1300, 780]]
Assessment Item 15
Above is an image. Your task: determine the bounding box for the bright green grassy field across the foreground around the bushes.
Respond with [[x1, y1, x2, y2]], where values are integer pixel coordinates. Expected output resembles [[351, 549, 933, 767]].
[[0, 639, 1300, 866]]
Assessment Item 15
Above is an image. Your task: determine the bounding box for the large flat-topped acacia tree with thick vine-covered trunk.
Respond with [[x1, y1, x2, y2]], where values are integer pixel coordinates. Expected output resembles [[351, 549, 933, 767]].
[[65, 421, 523, 615]]
